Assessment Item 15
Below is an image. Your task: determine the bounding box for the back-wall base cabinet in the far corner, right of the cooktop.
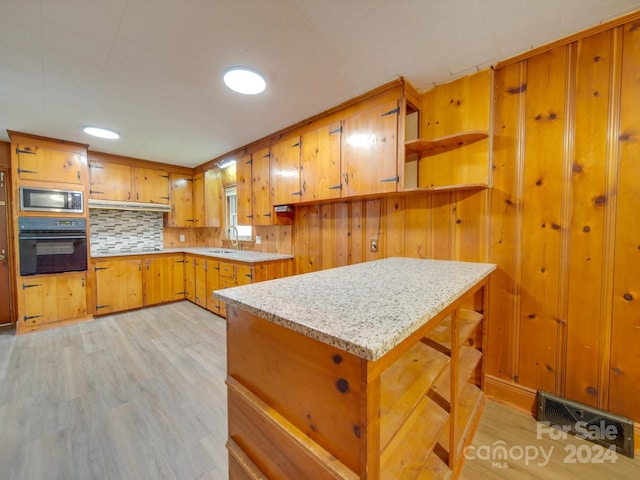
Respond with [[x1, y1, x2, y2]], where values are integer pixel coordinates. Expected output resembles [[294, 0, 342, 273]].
[[143, 255, 185, 305]]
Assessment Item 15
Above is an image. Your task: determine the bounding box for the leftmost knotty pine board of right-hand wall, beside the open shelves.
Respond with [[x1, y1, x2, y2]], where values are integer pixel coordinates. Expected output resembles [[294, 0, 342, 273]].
[[485, 62, 527, 380]]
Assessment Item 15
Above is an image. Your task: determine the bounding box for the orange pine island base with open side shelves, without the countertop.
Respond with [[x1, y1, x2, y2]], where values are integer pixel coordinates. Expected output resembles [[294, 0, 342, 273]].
[[227, 279, 488, 480]]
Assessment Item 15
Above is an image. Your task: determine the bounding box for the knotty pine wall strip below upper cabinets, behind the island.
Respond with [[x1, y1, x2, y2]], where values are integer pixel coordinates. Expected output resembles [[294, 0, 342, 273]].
[[293, 192, 488, 273]]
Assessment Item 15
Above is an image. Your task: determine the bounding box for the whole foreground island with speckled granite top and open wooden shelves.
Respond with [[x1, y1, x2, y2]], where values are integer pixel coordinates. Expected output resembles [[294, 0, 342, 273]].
[[215, 258, 495, 479]]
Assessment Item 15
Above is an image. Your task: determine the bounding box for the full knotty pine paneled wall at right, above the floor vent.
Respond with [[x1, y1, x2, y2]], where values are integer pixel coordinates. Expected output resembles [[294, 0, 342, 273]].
[[487, 22, 640, 420]]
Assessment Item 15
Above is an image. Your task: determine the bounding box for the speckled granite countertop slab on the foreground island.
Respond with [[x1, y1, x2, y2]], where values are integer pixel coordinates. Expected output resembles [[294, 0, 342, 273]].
[[214, 258, 496, 360]]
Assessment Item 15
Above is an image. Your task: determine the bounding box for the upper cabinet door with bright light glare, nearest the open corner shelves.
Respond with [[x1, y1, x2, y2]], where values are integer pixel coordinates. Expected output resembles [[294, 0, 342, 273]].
[[342, 101, 399, 197]]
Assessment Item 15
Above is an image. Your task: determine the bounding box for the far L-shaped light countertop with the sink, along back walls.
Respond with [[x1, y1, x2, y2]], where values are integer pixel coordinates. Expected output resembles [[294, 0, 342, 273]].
[[91, 247, 293, 263]]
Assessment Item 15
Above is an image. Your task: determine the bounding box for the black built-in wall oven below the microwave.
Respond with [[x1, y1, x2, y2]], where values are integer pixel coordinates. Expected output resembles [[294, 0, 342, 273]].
[[18, 217, 87, 275]]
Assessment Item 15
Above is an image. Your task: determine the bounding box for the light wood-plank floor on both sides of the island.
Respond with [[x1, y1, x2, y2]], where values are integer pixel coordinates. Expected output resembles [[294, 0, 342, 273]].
[[0, 302, 640, 480]]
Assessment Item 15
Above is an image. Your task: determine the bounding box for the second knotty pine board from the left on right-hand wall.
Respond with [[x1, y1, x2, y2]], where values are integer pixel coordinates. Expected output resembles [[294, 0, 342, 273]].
[[518, 47, 568, 391]]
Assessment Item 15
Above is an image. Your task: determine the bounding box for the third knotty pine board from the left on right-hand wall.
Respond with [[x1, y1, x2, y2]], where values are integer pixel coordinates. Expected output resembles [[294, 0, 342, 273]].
[[564, 31, 611, 407]]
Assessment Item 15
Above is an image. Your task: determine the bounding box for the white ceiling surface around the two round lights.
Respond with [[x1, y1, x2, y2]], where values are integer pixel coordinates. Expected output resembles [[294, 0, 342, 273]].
[[0, 0, 640, 166]]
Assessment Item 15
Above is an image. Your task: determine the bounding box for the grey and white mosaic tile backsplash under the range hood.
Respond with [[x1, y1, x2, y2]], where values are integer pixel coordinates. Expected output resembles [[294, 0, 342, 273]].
[[89, 209, 163, 255]]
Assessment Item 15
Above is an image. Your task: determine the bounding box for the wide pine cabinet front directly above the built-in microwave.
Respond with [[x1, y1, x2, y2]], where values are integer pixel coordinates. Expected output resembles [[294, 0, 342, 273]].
[[17, 145, 87, 185]]
